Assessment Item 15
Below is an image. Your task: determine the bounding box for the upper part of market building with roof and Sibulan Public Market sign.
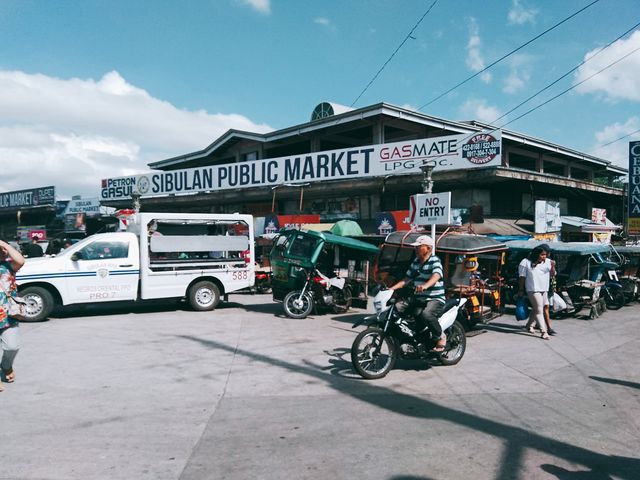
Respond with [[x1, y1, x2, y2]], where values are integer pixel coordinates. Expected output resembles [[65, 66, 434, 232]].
[[101, 103, 627, 237]]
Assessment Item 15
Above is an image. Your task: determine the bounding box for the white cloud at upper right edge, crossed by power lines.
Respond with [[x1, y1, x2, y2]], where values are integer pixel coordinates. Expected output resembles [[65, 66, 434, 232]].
[[575, 30, 640, 101]]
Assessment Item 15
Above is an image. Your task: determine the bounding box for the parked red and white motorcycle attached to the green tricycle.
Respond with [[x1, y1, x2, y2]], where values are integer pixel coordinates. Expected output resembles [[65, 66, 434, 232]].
[[283, 267, 352, 318]]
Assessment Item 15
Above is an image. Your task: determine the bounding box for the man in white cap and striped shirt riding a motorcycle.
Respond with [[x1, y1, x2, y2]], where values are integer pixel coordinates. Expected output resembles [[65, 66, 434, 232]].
[[390, 235, 447, 352]]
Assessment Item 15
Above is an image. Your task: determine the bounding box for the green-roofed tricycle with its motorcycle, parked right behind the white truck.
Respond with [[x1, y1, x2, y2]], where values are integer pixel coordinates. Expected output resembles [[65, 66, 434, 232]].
[[269, 230, 379, 318]]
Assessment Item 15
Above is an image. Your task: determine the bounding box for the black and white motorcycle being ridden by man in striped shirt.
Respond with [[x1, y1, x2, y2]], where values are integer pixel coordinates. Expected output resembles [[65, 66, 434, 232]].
[[351, 290, 467, 379]]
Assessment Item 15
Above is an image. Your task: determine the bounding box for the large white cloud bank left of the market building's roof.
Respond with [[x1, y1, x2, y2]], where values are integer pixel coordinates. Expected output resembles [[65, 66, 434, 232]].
[[0, 70, 270, 198]]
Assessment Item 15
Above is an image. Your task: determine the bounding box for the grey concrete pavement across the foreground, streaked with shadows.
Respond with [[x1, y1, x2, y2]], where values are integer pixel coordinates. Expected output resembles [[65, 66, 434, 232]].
[[0, 295, 640, 480]]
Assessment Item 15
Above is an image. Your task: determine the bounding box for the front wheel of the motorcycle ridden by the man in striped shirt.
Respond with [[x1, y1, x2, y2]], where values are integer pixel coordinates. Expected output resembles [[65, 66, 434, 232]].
[[351, 327, 397, 380]]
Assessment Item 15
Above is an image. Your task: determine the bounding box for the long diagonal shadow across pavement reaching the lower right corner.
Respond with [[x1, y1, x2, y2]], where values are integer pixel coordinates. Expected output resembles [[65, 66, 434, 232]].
[[176, 335, 640, 480]]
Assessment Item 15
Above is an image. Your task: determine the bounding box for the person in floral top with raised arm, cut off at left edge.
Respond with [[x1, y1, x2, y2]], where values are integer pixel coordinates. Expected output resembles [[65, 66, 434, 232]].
[[0, 240, 24, 391]]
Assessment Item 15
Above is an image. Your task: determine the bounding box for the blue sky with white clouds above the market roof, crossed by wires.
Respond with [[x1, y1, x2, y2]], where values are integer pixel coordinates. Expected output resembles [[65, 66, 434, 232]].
[[0, 0, 640, 198]]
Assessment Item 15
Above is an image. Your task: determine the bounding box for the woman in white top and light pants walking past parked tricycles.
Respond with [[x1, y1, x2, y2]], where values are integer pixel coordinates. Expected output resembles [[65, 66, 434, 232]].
[[518, 243, 553, 340]]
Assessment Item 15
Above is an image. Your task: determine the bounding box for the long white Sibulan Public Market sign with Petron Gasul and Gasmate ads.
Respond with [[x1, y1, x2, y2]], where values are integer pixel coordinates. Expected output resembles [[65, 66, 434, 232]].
[[101, 131, 502, 200]]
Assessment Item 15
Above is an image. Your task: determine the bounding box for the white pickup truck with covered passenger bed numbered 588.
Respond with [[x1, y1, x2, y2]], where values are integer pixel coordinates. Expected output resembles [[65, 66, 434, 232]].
[[16, 212, 255, 321]]
